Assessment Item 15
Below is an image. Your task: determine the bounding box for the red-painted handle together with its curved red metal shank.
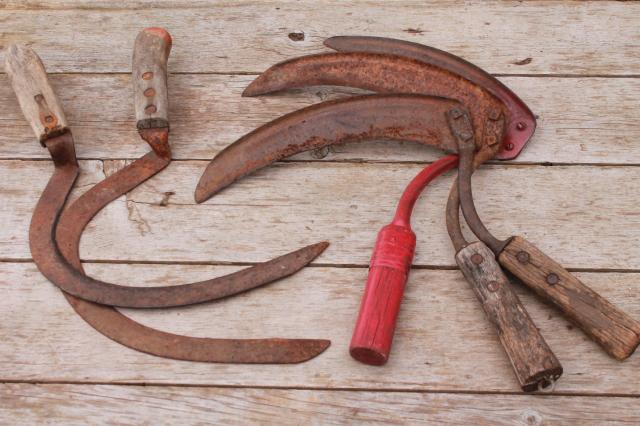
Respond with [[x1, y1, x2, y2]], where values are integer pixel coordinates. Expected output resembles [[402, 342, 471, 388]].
[[349, 155, 458, 365]]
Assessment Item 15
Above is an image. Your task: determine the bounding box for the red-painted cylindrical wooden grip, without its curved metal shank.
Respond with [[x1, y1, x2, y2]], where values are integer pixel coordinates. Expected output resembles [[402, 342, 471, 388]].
[[349, 224, 416, 365]]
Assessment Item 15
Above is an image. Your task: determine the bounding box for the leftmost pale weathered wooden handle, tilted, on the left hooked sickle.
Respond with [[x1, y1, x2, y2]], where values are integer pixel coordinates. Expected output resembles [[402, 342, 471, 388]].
[[5, 44, 68, 143]]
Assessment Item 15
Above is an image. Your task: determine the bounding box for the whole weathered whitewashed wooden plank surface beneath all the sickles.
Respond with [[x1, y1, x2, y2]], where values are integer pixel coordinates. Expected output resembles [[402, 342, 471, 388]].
[[0, 0, 640, 425]]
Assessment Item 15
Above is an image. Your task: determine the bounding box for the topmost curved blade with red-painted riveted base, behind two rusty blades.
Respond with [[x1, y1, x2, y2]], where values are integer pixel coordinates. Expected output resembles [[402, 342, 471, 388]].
[[324, 36, 536, 160]]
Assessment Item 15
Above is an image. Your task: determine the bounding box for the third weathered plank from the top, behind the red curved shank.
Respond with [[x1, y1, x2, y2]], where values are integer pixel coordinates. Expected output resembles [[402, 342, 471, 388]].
[[0, 160, 640, 270]]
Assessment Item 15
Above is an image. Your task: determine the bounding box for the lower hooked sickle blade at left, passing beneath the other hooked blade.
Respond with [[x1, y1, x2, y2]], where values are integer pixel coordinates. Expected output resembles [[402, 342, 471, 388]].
[[56, 141, 331, 364]]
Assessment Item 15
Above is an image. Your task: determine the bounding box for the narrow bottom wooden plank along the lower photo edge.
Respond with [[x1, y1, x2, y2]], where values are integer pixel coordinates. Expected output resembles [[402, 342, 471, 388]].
[[0, 384, 640, 426]]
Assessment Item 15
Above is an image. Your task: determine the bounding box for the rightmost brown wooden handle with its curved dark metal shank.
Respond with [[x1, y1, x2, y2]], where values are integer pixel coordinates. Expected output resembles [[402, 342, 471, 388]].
[[447, 112, 640, 360]]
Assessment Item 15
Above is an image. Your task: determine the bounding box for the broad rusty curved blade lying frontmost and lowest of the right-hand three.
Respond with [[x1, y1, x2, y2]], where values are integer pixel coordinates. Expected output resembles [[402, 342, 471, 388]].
[[195, 95, 460, 203]]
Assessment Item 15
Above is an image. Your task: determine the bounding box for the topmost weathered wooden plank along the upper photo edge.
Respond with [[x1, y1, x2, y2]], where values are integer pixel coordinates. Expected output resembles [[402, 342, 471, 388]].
[[0, 0, 640, 75]]
